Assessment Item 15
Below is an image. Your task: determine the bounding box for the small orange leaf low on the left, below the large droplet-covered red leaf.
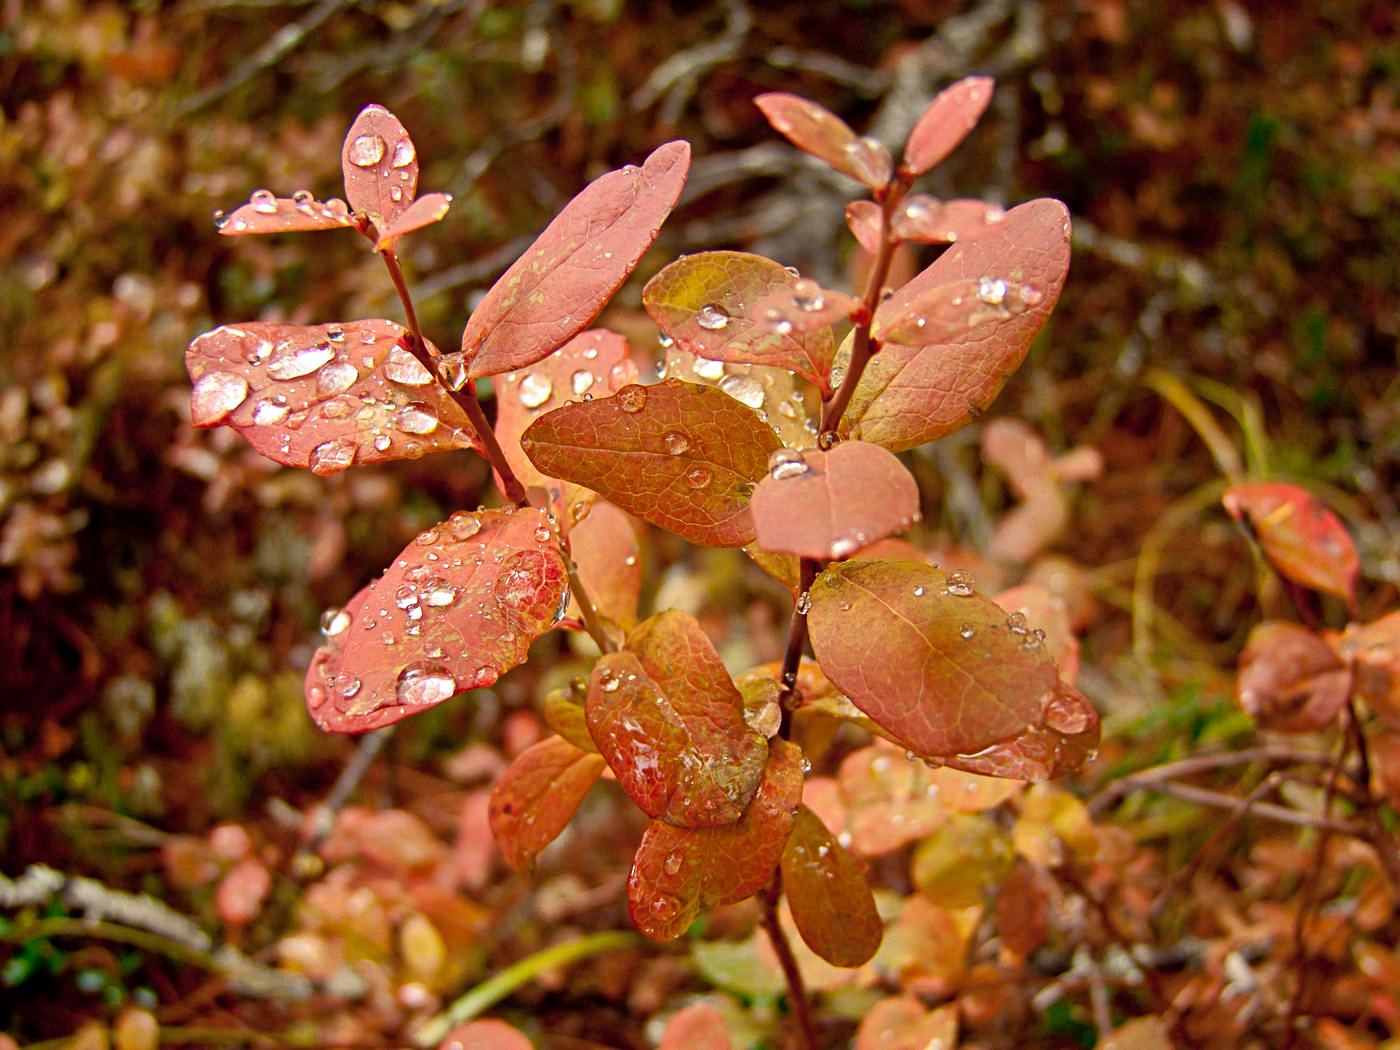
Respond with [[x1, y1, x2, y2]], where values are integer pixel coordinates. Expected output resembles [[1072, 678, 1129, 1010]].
[[490, 736, 603, 871]]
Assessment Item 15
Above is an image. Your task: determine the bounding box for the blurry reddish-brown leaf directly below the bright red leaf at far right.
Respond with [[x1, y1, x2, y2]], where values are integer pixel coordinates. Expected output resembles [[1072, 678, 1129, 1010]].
[[1235, 620, 1351, 732]]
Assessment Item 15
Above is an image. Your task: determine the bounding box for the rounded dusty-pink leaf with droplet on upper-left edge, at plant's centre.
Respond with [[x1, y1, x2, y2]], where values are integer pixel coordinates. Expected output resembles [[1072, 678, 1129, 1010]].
[[750, 441, 918, 561]]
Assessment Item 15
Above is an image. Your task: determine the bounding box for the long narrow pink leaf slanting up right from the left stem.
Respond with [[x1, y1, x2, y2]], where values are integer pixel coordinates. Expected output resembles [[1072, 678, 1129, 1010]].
[[462, 141, 690, 378]]
